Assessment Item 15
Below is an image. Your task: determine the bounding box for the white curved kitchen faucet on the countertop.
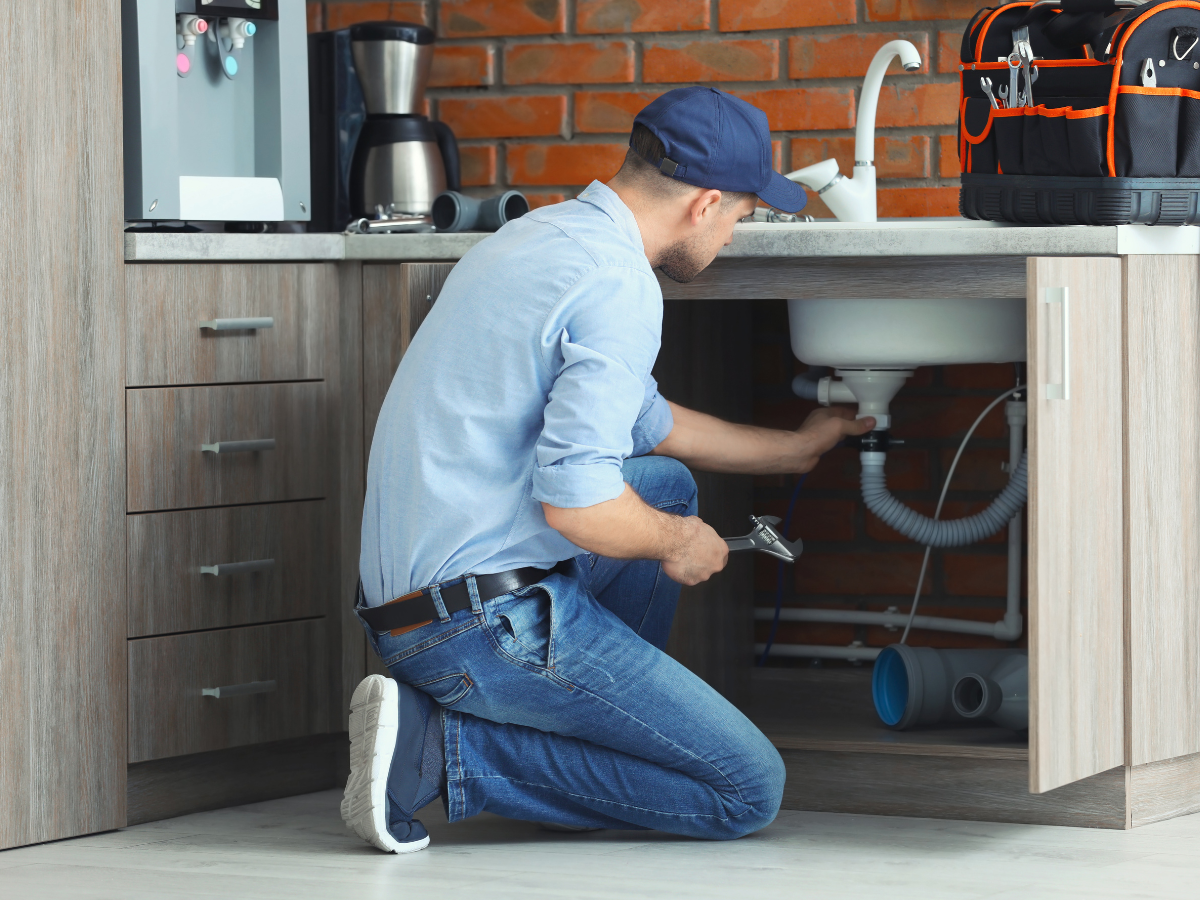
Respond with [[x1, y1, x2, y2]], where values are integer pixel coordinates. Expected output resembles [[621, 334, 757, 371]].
[[787, 41, 920, 222]]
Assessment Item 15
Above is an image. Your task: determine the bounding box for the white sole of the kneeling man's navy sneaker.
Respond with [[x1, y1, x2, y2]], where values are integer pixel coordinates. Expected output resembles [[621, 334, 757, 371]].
[[342, 674, 430, 853]]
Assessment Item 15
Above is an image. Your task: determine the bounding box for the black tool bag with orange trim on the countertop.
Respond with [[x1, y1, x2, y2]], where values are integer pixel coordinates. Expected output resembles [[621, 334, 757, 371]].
[[959, 0, 1200, 226]]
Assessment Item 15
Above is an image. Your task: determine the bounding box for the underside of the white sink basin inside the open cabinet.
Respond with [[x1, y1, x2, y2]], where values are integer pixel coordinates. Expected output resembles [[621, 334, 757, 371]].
[[787, 298, 1025, 368]]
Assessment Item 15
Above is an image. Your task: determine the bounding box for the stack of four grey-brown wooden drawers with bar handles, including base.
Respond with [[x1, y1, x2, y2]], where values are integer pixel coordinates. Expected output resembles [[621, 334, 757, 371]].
[[125, 263, 348, 822]]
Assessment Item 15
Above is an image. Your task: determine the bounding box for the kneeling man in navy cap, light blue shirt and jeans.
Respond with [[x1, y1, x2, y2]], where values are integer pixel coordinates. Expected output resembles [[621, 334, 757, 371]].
[[342, 88, 874, 852]]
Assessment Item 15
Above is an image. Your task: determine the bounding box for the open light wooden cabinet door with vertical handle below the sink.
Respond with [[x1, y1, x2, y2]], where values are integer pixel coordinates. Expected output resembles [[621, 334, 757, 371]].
[[1026, 257, 1124, 793]]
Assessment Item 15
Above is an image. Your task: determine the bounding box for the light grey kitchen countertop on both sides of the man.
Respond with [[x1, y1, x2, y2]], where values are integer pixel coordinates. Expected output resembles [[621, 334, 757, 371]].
[[125, 218, 1200, 263]]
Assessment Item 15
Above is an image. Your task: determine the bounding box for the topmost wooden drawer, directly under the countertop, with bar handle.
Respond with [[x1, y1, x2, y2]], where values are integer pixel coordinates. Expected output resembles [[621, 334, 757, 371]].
[[125, 264, 337, 386]]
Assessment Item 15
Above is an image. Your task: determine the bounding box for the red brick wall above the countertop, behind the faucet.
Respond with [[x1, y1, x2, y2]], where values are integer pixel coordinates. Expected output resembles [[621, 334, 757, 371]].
[[308, 0, 982, 217]]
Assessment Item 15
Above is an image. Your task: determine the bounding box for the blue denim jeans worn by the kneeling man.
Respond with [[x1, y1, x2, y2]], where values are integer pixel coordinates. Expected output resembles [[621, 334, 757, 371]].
[[355, 457, 784, 840]]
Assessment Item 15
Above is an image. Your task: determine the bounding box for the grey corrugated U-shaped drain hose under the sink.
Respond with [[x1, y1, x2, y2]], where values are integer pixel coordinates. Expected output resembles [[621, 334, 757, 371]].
[[862, 452, 1028, 547]]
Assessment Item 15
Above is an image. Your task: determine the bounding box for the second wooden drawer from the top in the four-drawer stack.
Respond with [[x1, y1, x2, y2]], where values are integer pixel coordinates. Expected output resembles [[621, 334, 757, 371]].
[[125, 382, 330, 512]]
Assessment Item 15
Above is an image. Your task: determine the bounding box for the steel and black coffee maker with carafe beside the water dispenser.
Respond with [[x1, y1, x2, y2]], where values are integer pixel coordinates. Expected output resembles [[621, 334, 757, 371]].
[[350, 22, 460, 218]]
